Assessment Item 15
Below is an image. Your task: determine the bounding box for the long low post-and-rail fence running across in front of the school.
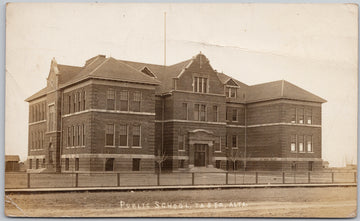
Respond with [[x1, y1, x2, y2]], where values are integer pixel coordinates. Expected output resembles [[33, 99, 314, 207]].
[[5, 171, 357, 189]]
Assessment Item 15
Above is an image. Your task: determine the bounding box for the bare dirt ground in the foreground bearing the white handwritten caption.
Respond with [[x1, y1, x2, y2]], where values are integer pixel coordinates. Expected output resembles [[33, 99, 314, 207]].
[[5, 187, 357, 217]]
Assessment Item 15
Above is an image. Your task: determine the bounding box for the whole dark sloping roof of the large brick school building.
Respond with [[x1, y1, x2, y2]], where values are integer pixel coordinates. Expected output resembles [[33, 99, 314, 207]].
[[26, 53, 326, 103]]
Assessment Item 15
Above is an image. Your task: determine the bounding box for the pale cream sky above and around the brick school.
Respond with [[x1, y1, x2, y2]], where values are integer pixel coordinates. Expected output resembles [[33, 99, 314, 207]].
[[5, 3, 358, 166]]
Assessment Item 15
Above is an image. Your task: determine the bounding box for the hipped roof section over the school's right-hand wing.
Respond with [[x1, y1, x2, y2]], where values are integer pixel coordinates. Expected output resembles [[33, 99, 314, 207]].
[[246, 80, 326, 103]]
